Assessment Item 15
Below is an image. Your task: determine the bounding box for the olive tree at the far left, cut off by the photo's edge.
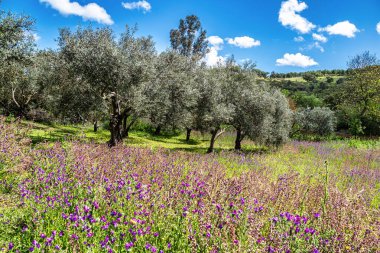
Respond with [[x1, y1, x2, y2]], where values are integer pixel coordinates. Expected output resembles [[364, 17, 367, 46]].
[[0, 4, 37, 116]]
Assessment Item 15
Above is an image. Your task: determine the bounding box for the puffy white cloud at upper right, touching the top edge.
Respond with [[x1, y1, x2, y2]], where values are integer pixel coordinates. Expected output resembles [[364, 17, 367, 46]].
[[278, 0, 316, 33]]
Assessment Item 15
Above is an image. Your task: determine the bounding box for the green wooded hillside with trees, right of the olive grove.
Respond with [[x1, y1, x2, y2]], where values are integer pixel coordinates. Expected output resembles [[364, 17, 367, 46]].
[[269, 51, 380, 136]]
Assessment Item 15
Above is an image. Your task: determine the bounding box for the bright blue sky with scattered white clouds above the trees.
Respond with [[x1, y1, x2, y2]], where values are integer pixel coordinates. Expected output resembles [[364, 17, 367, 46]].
[[1, 0, 380, 72]]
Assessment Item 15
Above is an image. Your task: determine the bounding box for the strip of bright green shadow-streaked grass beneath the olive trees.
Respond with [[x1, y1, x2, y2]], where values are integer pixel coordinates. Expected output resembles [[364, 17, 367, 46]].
[[22, 121, 265, 153]]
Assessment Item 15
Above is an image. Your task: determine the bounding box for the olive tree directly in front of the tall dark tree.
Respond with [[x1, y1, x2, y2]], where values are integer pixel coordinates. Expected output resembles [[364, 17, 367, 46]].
[[148, 51, 196, 135]]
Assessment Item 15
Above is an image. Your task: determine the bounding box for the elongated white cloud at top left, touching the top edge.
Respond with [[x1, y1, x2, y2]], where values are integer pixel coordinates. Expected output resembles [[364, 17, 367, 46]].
[[40, 0, 113, 25]]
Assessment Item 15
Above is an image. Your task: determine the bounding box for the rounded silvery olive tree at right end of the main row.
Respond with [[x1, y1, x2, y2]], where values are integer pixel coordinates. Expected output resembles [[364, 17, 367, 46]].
[[223, 59, 291, 150]]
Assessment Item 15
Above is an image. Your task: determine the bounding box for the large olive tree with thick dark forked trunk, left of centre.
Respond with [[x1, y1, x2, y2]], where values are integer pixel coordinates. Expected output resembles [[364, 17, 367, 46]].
[[59, 27, 155, 146]]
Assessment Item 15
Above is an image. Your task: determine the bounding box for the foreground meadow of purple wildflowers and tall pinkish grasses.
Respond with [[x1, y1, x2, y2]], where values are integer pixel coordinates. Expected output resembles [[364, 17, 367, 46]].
[[0, 119, 380, 252]]
